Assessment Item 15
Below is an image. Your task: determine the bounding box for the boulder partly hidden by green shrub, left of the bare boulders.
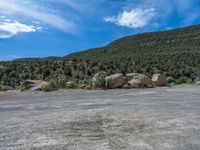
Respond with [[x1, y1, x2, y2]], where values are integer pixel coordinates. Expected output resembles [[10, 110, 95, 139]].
[[92, 72, 106, 88]]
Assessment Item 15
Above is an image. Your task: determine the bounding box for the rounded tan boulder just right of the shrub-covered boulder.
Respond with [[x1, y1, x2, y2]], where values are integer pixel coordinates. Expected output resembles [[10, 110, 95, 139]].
[[105, 73, 125, 89]]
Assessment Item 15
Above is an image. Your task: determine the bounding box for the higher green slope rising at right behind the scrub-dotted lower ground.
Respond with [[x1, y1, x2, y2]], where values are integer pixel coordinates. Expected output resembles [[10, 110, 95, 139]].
[[67, 25, 200, 60]]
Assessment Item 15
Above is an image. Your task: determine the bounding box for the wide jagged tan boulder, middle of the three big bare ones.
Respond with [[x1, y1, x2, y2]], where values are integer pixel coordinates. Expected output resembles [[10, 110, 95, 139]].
[[126, 73, 152, 88]]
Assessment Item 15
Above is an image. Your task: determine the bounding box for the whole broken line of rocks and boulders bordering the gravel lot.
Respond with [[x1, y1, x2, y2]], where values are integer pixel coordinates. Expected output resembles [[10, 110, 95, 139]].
[[18, 72, 200, 91]]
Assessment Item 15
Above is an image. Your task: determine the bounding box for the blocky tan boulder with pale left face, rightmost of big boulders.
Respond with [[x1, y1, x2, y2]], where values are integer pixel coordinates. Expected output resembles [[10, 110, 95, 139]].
[[152, 74, 167, 86]]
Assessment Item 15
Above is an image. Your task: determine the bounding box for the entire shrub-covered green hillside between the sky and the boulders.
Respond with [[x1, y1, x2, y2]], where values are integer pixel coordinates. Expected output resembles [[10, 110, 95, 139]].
[[0, 25, 200, 87]]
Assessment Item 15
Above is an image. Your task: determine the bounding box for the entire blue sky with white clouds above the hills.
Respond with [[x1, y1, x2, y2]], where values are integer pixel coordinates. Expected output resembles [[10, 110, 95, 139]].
[[0, 0, 200, 60]]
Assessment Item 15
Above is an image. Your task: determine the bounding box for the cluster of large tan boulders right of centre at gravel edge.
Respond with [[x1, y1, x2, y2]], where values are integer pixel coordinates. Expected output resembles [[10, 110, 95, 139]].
[[93, 73, 167, 89]]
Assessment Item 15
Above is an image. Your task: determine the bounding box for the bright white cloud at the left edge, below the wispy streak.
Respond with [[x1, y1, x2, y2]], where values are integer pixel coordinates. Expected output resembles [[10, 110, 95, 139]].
[[0, 21, 41, 38]]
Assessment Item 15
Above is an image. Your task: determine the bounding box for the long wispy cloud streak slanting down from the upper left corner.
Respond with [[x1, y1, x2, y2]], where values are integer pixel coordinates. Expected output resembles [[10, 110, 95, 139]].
[[0, 0, 76, 33]]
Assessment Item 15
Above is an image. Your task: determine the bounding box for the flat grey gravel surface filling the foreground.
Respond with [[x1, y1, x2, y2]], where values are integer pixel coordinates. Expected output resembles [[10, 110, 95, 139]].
[[0, 87, 200, 150]]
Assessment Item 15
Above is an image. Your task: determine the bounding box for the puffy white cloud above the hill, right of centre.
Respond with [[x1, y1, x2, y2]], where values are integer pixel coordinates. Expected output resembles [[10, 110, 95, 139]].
[[104, 8, 156, 29]]
